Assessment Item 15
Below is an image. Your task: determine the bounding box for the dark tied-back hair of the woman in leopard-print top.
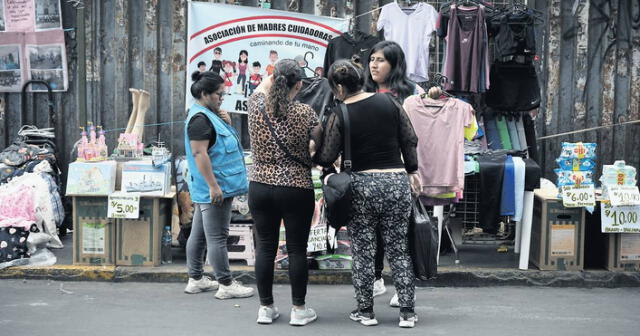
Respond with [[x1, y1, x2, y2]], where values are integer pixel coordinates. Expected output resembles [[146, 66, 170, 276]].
[[267, 59, 304, 117]]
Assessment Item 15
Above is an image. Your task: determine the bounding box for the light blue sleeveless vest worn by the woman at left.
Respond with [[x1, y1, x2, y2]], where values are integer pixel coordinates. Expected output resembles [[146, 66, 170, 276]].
[[184, 103, 249, 203]]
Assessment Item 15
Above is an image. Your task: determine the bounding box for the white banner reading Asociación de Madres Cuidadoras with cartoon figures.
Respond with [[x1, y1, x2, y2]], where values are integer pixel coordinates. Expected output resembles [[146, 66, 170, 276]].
[[186, 2, 348, 113]]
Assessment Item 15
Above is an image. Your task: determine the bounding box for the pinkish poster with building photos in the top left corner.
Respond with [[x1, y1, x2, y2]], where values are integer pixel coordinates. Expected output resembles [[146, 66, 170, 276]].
[[0, 0, 68, 92]]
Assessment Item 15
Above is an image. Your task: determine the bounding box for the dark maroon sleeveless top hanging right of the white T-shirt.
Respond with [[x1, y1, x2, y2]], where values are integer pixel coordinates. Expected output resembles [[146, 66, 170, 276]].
[[444, 5, 489, 93]]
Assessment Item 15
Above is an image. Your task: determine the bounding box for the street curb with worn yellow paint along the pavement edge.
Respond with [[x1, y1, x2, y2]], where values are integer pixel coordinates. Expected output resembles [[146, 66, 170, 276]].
[[0, 265, 640, 288]]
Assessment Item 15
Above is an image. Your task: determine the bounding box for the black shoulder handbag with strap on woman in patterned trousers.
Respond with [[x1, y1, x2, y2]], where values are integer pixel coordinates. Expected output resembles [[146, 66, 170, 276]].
[[322, 104, 352, 230]]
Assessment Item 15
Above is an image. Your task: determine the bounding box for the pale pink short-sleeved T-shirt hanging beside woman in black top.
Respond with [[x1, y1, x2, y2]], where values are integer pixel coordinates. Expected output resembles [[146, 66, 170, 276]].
[[404, 95, 474, 195]]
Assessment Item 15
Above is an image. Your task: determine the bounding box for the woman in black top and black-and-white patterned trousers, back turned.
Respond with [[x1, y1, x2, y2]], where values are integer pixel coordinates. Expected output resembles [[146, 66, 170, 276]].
[[315, 60, 420, 327]]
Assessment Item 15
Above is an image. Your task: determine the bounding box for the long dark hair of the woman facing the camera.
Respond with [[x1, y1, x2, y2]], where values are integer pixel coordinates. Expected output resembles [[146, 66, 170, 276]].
[[364, 41, 416, 102]]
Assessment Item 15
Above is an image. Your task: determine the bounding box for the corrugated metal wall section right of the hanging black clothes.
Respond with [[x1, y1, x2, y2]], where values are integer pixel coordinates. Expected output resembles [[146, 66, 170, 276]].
[[530, 0, 640, 180]]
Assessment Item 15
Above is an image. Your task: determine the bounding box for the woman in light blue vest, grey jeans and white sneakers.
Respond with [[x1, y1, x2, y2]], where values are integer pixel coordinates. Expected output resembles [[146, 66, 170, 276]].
[[184, 71, 253, 299]]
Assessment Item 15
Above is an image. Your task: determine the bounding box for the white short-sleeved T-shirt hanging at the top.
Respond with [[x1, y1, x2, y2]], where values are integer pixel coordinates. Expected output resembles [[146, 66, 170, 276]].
[[377, 2, 438, 82]]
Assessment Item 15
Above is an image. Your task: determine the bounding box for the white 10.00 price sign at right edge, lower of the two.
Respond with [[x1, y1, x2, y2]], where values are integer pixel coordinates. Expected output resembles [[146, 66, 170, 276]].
[[600, 202, 640, 233]]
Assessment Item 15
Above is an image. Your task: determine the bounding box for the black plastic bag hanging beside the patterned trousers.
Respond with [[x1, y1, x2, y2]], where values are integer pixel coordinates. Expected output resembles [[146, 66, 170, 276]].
[[409, 199, 438, 280]]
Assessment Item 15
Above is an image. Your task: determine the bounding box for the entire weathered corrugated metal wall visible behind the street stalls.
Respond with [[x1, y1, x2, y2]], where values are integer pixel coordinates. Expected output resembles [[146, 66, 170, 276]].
[[0, 0, 640, 184]]
